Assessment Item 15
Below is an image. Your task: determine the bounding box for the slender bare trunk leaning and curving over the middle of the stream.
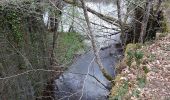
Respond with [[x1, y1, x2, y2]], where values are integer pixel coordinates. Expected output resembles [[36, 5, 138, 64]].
[[81, 0, 113, 81]]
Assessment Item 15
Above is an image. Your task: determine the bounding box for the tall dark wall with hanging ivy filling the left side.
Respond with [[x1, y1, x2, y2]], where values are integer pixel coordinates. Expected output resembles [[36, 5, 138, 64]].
[[0, 0, 51, 100]]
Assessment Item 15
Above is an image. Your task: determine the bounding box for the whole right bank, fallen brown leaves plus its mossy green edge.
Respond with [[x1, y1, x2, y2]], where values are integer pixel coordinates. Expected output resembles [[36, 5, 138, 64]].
[[110, 2, 170, 100]]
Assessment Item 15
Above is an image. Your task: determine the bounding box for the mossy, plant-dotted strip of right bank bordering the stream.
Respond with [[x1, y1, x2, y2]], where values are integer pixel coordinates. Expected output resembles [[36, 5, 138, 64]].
[[110, 44, 149, 100]]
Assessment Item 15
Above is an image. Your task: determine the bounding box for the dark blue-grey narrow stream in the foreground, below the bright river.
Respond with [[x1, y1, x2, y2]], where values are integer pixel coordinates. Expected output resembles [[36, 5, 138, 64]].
[[55, 46, 122, 100]]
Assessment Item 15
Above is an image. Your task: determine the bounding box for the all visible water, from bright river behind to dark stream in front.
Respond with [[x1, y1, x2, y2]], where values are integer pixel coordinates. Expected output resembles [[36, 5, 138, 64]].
[[44, 2, 125, 100]]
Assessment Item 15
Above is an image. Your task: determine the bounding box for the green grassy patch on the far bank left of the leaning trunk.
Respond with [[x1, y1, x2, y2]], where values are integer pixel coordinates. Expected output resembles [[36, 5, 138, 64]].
[[56, 32, 84, 64]]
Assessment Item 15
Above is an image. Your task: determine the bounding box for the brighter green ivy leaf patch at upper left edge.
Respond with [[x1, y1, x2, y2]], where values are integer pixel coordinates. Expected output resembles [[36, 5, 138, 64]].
[[0, 6, 23, 43]]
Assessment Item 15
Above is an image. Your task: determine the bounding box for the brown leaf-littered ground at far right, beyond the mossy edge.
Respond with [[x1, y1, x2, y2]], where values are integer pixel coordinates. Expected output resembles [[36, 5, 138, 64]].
[[141, 35, 170, 100]]
